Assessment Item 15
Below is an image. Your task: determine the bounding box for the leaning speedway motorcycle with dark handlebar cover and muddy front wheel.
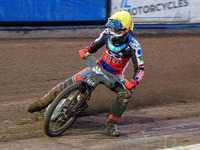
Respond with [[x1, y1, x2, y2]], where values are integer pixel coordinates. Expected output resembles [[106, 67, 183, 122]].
[[44, 53, 126, 137]]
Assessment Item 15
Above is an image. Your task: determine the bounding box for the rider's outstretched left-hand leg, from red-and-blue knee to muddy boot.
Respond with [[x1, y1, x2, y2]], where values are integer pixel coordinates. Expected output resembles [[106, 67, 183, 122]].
[[26, 68, 89, 113]]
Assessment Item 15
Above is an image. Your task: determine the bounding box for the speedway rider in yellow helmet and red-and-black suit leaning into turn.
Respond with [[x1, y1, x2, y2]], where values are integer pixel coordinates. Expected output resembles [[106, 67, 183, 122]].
[[27, 11, 144, 136]]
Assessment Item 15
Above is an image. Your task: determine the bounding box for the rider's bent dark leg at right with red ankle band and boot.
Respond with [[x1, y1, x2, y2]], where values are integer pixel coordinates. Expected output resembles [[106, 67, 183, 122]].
[[105, 81, 133, 136]]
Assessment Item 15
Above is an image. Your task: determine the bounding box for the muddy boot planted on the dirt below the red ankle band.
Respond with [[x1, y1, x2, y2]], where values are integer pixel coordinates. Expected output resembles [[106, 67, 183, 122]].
[[105, 119, 121, 136]]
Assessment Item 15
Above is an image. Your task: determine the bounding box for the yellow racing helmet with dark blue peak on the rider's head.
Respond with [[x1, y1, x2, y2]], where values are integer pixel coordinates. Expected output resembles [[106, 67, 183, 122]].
[[105, 11, 134, 45]]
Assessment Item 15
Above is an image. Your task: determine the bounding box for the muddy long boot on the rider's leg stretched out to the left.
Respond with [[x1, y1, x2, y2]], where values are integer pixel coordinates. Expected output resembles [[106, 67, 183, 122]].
[[26, 78, 74, 113]]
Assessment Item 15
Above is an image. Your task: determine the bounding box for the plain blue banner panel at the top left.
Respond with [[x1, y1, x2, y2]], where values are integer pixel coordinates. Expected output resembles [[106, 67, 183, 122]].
[[0, 0, 106, 22]]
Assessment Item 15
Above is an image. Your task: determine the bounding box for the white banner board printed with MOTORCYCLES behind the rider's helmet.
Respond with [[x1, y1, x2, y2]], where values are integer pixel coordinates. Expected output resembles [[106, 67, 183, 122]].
[[111, 0, 200, 24]]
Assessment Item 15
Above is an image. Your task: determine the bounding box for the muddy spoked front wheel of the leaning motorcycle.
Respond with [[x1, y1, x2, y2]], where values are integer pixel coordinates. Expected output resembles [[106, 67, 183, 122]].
[[44, 84, 86, 137]]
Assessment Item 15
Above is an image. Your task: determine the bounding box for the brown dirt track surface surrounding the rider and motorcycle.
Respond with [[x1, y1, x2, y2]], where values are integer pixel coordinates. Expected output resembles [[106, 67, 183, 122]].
[[0, 34, 200, 150]]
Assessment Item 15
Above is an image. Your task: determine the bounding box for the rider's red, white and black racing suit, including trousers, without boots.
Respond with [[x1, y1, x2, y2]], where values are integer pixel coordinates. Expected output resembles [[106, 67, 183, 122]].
[[73, 29, 144, 121]]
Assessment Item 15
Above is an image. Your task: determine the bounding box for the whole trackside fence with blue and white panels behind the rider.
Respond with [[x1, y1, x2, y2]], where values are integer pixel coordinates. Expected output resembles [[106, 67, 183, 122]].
[[0, 0, 200, 29]]
